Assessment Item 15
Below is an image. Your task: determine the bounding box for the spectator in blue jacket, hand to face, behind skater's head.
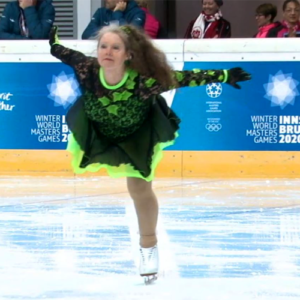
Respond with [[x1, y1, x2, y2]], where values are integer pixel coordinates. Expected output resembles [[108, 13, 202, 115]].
[[82, 0, 146, 40]]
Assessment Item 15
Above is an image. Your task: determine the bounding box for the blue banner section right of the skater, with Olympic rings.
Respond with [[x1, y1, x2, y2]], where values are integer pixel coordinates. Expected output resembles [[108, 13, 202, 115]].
[[169, 62, 300, 151]]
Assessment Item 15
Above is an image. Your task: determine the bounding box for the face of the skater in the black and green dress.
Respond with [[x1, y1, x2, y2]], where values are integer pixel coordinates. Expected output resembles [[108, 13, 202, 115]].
[[98, 32, 129, 70]]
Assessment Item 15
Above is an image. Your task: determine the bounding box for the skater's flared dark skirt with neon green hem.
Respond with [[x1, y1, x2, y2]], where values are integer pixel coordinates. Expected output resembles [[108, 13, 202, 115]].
[[67, 96, 180, 181]]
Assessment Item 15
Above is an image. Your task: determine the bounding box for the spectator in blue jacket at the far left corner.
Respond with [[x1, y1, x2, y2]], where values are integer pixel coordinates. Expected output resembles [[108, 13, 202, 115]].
[[0, 0, 55, 40]]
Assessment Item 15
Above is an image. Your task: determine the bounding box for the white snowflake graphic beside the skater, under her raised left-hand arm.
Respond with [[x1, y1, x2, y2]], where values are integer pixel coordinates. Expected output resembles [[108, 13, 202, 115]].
[[47, 72, 81, 108]]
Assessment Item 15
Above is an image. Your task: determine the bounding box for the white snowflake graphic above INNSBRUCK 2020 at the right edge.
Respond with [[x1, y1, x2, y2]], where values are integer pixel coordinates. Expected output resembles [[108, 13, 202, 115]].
[[264, 71, 299, 109]]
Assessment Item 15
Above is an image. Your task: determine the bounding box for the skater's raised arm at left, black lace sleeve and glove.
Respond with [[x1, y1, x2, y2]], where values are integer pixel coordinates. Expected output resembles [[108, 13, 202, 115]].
[[49, 27, 94, 86]]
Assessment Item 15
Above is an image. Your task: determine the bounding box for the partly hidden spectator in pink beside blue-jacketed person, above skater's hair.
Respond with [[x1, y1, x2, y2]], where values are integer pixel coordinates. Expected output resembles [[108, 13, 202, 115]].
[[136, 0, 168, 39]]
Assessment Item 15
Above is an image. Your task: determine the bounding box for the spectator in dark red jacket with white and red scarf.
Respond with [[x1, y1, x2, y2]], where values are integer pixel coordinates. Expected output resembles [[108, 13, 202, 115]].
[[184, 0, 231, 39]]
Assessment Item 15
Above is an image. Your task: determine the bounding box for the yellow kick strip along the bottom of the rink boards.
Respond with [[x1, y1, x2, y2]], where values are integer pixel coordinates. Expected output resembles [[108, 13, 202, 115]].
[[0, 150, 300, 178]]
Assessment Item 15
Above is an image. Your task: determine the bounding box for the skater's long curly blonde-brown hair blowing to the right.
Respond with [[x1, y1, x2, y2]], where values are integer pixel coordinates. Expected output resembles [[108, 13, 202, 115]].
[[97, 25, 176, 88]]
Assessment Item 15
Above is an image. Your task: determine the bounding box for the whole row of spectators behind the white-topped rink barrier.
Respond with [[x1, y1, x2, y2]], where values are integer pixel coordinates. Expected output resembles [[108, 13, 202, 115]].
[[0, 0, 300, 40]]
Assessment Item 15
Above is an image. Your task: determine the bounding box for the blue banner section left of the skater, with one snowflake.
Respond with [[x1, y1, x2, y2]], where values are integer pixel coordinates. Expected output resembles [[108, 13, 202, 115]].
[[0, 63, 80, 149]]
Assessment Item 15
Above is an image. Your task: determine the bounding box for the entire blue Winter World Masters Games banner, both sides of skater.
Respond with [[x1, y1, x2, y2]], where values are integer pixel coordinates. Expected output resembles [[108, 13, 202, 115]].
[[0, 62, 300, 151]]
